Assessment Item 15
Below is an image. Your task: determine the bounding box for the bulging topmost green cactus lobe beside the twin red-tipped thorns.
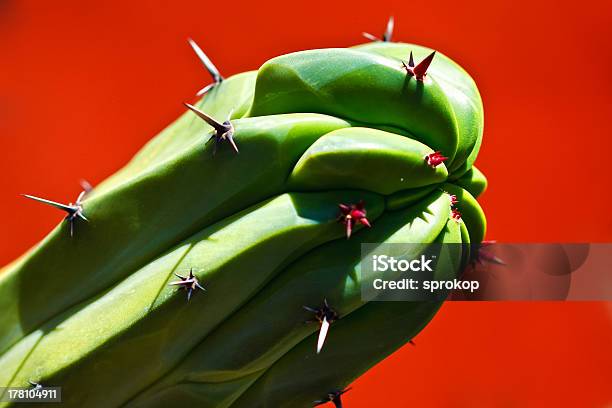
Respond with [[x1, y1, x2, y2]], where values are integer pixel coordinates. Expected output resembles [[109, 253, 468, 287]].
[[247, 49, 459, 164]]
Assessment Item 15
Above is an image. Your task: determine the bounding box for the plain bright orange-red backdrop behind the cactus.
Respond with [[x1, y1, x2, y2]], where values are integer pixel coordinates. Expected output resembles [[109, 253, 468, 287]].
[[0, 0, 612, 408]]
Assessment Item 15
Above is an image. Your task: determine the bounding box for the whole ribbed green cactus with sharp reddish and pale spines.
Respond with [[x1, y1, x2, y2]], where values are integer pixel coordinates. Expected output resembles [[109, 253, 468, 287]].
[[0, 16, 486, 407]]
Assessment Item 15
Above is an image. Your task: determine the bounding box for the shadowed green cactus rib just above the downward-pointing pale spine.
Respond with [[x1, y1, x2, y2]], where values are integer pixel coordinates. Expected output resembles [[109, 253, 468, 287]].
[[126, 191, 450, 406]]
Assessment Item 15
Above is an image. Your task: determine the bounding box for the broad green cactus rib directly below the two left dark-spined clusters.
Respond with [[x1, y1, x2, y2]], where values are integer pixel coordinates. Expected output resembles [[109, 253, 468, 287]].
[[0, 114, 347, 351]]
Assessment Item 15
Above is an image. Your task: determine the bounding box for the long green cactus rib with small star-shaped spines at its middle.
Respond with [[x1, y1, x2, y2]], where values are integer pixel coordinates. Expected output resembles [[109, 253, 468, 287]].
[[0, 191, 384, 406]]
